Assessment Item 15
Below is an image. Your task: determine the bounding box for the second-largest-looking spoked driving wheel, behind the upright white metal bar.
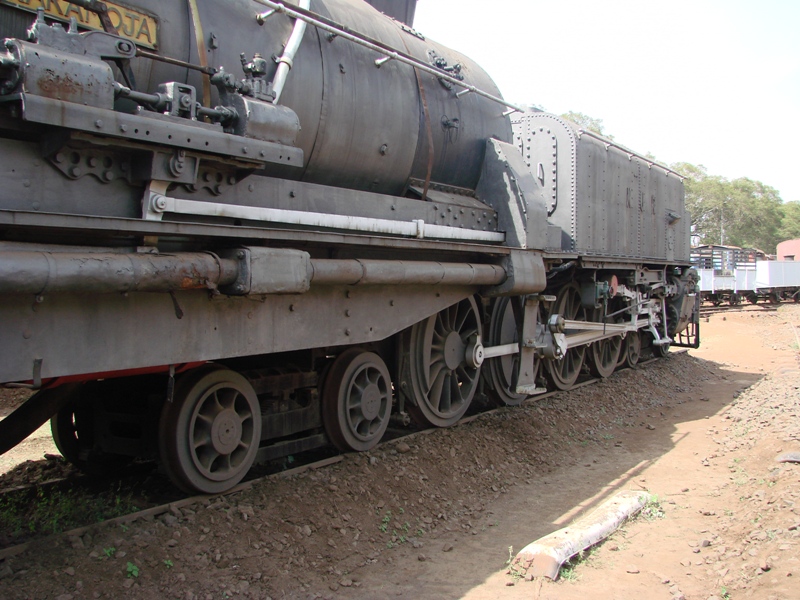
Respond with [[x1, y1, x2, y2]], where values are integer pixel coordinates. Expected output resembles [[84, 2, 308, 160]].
[[487, 297, 541, 406]]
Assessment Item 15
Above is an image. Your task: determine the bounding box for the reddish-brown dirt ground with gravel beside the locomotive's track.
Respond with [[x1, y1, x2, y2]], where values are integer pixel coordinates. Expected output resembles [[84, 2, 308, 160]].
[[0, 305, 800, 600]]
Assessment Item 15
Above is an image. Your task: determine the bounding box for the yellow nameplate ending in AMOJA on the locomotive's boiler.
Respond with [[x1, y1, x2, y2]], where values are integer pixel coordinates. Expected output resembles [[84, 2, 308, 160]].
[[0, 0, 158, 48]]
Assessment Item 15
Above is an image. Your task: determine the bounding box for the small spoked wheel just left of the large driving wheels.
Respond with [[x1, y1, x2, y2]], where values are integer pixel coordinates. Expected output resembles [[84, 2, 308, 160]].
[[322, 348, 392, 452]]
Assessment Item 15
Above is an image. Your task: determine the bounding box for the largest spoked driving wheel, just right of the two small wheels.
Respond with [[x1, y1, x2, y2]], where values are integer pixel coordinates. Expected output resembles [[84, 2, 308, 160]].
[[408, 297, 481, 427]]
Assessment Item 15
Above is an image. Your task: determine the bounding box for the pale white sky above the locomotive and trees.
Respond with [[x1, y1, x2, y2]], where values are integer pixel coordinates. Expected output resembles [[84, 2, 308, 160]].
[[414, 0, 800, 202]]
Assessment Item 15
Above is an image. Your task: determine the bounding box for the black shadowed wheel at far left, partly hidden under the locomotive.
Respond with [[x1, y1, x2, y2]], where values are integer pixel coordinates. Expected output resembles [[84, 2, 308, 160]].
[[50, 382, 133, 475]]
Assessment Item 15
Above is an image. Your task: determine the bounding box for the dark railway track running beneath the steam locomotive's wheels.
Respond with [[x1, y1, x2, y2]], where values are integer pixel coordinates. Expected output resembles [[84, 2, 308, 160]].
[[0, 350, 668, 560]]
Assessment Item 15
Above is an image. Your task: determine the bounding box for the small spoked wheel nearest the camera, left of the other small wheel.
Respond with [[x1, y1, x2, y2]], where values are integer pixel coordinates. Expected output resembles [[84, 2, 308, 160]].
[[159, 365, 261, 494]]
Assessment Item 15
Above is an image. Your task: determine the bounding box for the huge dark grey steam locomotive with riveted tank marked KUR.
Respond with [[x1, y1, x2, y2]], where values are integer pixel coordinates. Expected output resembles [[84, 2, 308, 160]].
[[0, 0, 699, 493]]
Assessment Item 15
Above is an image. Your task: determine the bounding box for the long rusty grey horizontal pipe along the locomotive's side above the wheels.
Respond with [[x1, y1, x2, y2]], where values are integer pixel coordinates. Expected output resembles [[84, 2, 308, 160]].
[[0, 249, 507, 295]]
